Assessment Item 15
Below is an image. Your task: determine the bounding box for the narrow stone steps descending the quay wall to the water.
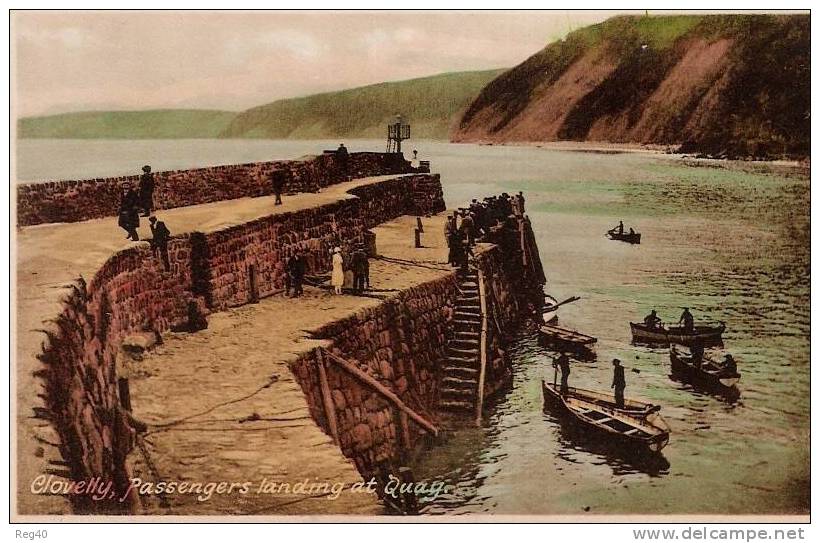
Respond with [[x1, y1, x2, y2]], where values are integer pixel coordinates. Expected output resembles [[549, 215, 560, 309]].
[[438, 270, 482, 414]]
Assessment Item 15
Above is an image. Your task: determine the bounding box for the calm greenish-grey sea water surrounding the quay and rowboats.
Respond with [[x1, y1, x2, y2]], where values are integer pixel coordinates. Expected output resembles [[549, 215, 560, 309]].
[[17, 140, 810, 514]]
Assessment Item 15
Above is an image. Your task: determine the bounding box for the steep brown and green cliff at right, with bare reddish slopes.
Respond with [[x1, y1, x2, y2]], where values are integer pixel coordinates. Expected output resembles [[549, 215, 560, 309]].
[[451, 15, 811, 158]]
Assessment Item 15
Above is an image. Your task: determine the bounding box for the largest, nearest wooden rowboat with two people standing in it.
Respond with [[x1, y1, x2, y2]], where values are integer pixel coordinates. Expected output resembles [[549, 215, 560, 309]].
[[541, 381, 670, 452]]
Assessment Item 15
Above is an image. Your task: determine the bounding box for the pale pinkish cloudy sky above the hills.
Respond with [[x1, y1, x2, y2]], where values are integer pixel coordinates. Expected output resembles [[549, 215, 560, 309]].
[[12, 11, 644, 116]]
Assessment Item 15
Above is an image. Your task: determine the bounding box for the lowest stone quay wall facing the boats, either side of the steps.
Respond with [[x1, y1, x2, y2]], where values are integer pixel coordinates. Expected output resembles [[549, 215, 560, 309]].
[[291, 224, 543, 478]]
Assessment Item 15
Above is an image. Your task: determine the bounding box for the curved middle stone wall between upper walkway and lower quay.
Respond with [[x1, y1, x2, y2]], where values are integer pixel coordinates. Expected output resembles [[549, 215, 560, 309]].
[[37, 175, 444, 513]]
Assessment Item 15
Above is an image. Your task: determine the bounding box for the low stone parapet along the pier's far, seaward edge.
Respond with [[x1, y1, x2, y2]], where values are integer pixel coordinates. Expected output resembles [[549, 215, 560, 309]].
[[17, 153, 412, 226]]
